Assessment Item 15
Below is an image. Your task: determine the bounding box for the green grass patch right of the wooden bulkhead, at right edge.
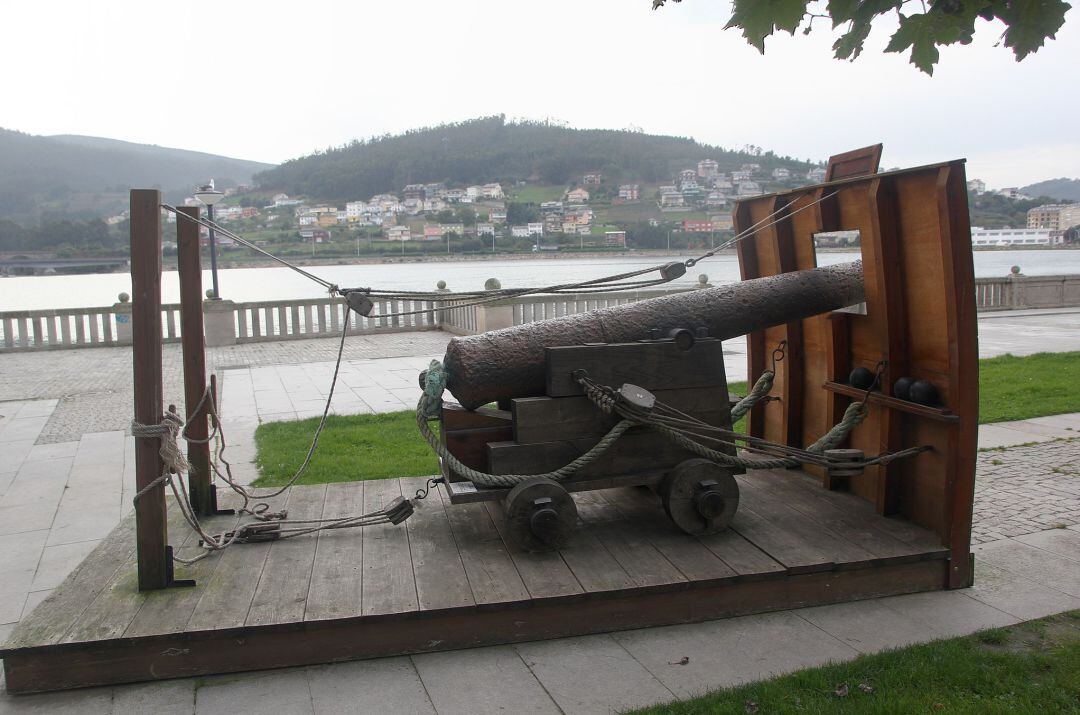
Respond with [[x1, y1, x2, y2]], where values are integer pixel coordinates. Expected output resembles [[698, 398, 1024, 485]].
[[978, 352, 1080, 423]]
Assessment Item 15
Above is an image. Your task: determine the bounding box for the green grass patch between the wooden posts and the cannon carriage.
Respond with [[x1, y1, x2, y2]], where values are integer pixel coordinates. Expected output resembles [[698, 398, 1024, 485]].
[[255, 412, 438, 486]]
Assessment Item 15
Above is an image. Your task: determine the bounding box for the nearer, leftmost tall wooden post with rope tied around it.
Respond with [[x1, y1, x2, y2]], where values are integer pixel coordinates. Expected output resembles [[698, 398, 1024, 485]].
[[131, 189, 172, 591]]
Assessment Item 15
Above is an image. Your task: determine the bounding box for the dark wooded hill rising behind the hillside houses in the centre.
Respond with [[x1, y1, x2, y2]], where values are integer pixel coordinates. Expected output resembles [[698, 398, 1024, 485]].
[[255, 116, 811, 201]]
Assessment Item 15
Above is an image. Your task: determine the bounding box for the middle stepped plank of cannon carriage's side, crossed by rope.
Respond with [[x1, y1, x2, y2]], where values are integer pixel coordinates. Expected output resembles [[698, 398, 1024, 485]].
[[511, 385, 731, 444]]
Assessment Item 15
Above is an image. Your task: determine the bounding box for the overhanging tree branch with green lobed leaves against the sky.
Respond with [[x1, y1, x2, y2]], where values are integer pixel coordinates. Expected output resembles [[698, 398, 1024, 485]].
[[652, 0, 1071, 75]]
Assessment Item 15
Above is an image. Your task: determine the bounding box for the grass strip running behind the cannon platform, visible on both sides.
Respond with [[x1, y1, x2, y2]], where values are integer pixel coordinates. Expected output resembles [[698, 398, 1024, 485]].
[[255, 352, 1080, 486]]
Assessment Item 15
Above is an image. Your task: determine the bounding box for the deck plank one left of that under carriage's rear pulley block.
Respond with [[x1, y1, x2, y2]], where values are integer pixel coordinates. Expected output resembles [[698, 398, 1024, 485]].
[[303, 482, 366, 621]]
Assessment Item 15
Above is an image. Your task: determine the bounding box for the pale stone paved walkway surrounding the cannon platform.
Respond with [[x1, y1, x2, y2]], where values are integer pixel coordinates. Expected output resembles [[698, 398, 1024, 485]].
[[0, 311, 1080, 714]]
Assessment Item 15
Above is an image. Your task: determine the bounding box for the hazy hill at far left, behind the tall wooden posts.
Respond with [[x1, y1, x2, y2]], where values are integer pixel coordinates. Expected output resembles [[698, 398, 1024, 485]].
[[0, 129, 271, 224]]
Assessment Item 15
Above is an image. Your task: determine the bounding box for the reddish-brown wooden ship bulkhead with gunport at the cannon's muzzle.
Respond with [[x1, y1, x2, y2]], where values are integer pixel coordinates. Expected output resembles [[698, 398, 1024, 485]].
[[733, 161, 978, 585]]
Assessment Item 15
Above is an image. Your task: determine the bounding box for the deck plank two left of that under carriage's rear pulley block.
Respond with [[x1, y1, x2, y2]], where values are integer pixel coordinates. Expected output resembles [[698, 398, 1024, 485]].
[[244, 484, 326, 625]]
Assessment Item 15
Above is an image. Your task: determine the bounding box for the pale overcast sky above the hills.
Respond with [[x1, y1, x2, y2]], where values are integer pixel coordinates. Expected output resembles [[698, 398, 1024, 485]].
[[0, 0, 1080, 187]]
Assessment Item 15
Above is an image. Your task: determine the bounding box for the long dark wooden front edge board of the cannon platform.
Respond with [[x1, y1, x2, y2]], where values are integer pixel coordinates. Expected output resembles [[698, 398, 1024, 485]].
[[3, 561, 945, 693]]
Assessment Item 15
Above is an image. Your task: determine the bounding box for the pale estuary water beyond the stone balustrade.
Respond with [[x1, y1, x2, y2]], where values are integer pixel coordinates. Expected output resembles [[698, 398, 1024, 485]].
[[0, 251, 1080, 311]]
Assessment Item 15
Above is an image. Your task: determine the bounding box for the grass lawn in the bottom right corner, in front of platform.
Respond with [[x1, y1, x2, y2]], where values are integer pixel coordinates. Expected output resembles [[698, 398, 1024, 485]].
[[635, 611, 1080, 715]]
